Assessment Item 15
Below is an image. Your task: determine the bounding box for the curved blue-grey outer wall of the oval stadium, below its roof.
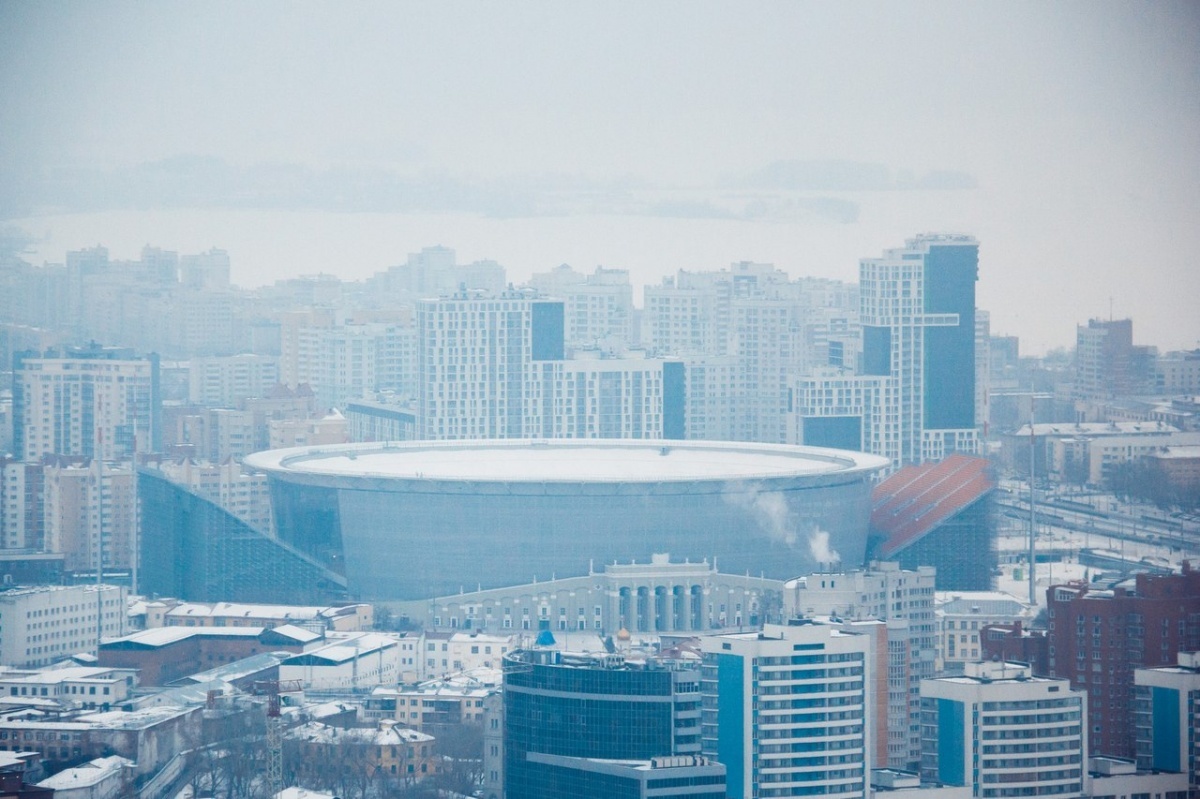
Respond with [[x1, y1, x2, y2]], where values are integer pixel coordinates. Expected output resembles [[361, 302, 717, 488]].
[[247, 441, 882, 600]]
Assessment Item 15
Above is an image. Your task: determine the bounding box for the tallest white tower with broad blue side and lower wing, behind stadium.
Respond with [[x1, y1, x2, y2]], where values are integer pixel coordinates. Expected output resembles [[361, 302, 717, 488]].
[[790, 234, 980, 467]]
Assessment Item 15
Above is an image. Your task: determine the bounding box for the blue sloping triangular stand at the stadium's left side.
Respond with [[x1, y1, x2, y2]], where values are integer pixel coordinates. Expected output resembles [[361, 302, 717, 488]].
[[138, 469, 346, 605]]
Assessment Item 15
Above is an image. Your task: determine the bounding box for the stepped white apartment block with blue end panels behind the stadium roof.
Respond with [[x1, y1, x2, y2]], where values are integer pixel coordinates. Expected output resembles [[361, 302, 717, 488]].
[[416, 290, 684, 439]]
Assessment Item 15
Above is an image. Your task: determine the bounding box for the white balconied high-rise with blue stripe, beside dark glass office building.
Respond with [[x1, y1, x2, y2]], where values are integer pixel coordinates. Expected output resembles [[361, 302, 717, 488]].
[[701, 619, 874, 799]]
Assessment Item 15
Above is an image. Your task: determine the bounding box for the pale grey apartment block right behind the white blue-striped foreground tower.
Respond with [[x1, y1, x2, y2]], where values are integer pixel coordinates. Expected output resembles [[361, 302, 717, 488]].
[[784, 561, 937, 771]]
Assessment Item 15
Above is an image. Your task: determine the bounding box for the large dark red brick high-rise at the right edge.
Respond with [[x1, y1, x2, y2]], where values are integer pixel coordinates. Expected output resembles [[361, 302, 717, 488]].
[[1046, 563, 1200, 758]]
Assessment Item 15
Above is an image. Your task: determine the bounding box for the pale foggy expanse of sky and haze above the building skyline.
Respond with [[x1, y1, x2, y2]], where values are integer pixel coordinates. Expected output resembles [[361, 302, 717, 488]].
[[0, 2, 1200, 353]]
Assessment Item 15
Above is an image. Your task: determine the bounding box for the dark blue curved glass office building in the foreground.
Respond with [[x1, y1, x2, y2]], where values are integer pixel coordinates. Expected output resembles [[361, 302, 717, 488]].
[[503, 649, 725, 799]]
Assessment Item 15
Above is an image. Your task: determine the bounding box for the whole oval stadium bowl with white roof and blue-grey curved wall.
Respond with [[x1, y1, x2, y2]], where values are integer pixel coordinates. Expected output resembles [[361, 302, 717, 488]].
[[238, 439, 887, 600]]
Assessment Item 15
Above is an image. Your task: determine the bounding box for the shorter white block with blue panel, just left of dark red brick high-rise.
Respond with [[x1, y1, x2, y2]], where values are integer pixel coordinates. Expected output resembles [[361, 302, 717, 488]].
[[920, 662, 1087, 799]]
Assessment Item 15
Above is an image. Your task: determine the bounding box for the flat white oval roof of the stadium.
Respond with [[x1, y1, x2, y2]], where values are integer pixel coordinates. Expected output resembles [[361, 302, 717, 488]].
[[245, 439, 888, 482]]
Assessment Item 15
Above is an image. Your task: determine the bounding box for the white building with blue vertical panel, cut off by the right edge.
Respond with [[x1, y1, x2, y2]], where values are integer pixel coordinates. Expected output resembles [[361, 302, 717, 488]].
[[1134, 651, 1200, 797]]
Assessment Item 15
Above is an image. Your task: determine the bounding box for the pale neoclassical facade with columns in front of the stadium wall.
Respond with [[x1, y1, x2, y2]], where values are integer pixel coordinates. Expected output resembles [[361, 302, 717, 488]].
[[388, 553, 784, 635]]
